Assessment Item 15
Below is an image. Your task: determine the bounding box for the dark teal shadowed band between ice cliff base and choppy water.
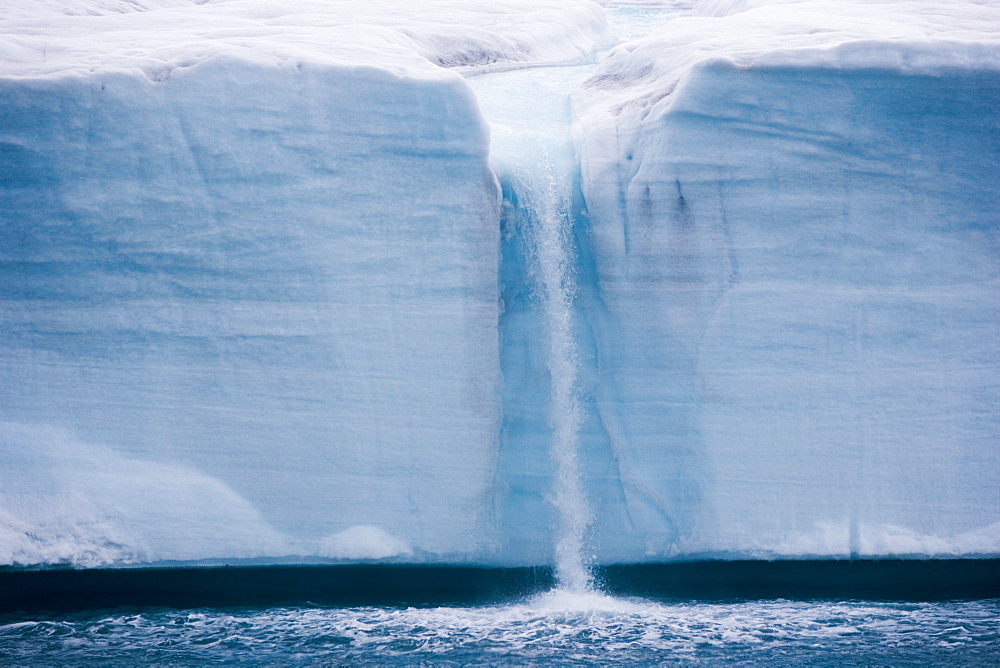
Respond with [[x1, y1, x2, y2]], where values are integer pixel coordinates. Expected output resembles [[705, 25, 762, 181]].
[[0, 559, 1000, 613]]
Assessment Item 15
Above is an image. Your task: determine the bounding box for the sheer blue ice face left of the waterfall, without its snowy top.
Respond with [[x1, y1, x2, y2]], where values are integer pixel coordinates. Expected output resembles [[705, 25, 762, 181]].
[[0, 61, 499, 558]]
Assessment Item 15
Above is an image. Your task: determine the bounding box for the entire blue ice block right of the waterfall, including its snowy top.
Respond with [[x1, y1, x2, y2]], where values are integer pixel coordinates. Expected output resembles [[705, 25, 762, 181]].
[[575, 0, 1000, 559]]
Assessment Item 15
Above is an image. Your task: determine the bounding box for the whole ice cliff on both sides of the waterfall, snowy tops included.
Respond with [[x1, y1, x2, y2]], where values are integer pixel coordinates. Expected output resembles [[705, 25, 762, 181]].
[[0, 0, 1000, 565]]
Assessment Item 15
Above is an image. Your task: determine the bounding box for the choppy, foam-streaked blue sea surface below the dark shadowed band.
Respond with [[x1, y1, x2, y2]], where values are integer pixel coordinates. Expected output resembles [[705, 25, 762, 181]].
[[0, 591, 1000, 666]]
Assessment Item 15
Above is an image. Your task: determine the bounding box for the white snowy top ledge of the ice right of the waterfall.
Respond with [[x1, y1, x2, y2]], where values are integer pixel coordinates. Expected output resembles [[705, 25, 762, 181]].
[[574, 0, 1000, 119]]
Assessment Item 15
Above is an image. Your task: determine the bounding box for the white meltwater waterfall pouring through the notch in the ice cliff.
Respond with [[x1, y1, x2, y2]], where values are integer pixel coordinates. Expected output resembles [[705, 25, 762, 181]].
[[471, 66, 593, 592]]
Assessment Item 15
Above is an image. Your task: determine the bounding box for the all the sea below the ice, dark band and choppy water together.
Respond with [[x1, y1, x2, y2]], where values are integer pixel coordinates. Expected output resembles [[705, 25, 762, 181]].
[[0, 559, 1000, 666]]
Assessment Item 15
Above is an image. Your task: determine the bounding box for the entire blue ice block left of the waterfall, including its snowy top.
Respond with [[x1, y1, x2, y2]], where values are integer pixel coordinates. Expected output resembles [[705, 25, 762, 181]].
[[0, 0, 624, 564]]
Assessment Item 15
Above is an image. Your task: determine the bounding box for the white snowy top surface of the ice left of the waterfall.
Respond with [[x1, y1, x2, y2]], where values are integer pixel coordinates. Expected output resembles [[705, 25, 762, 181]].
[[0, 0, 612, 73]]
